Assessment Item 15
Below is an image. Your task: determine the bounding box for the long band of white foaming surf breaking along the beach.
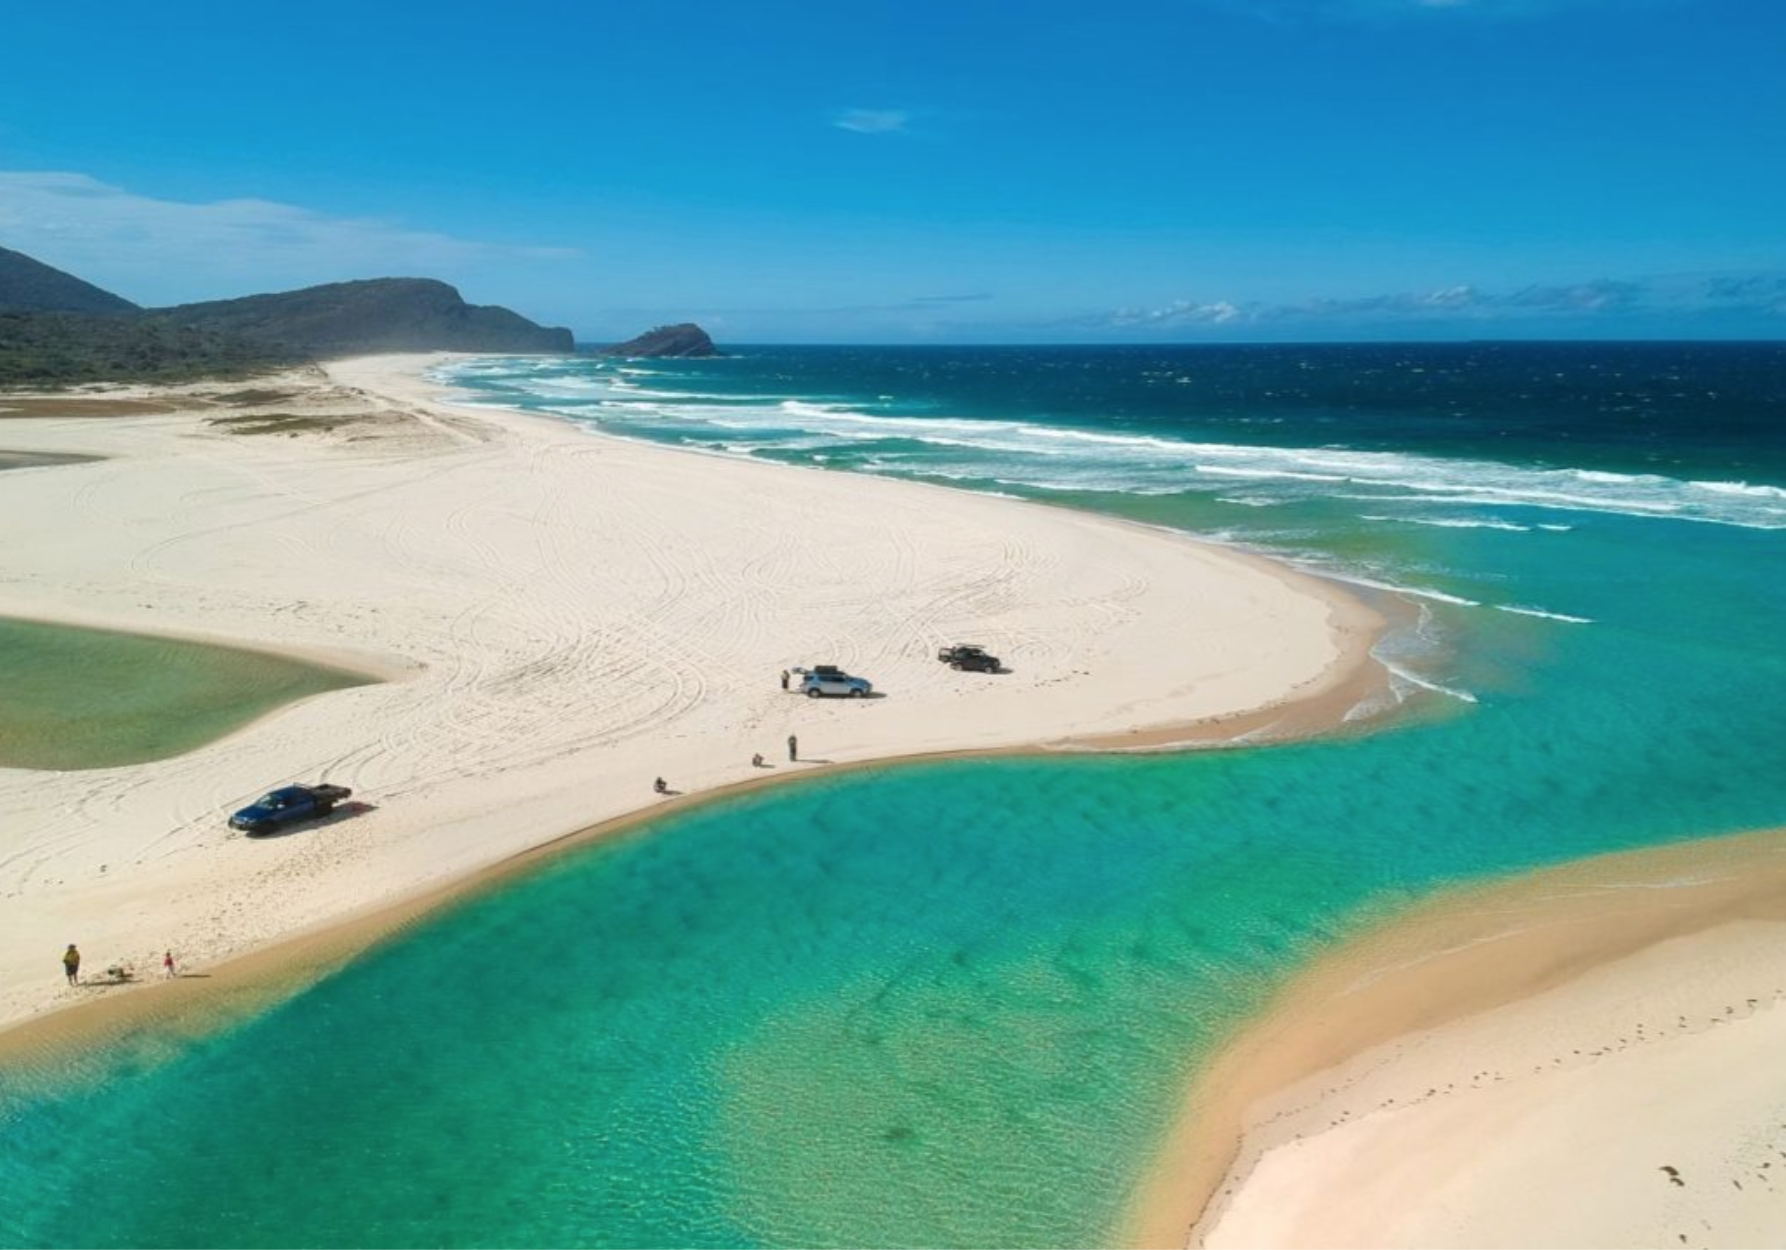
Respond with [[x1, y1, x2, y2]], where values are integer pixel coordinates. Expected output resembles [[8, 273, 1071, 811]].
[[438, 359, 1786, 532]]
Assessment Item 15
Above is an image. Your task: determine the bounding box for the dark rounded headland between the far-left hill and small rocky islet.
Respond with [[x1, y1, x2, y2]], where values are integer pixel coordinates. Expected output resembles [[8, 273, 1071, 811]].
[[145, 279, 573, 357]]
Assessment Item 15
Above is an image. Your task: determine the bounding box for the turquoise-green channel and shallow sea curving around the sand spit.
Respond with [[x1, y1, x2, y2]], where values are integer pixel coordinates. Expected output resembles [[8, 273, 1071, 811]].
[[0, 344, 1786, 1246]]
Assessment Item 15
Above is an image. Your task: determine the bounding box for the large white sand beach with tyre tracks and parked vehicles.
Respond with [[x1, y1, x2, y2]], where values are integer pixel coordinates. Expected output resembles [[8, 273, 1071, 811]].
[[0, 357, 1381, 1023]]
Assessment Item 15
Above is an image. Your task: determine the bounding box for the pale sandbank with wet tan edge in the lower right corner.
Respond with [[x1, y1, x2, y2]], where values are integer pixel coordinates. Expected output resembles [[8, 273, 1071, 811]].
[[1122, 829, 1786, 1246]]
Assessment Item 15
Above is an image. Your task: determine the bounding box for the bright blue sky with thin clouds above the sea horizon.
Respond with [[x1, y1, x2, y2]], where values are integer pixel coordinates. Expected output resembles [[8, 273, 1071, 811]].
[[0, 0, 1786, 343]]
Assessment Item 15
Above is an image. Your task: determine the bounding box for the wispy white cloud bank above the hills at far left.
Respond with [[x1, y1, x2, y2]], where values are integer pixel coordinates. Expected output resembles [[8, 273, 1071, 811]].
[[0, 170, 579, 305]]
